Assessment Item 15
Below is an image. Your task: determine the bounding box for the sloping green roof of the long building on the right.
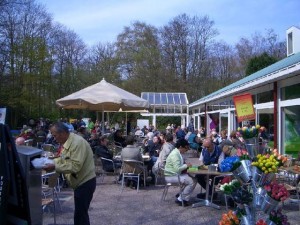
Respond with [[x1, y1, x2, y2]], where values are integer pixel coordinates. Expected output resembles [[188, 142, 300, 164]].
[[190, 52, 300, 105]]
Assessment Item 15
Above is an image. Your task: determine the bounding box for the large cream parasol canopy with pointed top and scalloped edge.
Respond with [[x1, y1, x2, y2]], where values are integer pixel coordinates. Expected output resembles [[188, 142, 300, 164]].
[[56, 79, 149, 111]]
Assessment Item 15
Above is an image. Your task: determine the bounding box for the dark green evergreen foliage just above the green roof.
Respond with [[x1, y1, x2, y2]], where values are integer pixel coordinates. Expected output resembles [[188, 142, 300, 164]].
[[246, 52, 278, 75]]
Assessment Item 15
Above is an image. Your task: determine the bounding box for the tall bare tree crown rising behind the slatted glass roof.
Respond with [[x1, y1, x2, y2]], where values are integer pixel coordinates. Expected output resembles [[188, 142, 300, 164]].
[[161, 14, 218, 100]]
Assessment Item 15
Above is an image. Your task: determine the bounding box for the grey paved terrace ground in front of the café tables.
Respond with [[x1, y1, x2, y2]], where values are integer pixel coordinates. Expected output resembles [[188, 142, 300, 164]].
[[43, 176, 300, 225]]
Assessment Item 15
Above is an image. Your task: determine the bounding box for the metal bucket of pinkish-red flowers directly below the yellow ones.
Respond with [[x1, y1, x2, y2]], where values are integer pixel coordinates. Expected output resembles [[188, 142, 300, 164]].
[[261, 182, 289, 213]]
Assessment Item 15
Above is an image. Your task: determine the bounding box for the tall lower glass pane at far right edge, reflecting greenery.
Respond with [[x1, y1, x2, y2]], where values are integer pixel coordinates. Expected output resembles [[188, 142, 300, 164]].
[[283, 105, 300, 158]]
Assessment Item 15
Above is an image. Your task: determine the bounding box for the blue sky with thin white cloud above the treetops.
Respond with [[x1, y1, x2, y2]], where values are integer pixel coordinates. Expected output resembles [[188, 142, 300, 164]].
[[36, 0, 300, 46]]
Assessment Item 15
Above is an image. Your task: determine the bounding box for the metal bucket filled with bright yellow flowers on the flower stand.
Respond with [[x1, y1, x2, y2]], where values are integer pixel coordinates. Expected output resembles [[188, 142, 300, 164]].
[[251, 149, 287, 186]]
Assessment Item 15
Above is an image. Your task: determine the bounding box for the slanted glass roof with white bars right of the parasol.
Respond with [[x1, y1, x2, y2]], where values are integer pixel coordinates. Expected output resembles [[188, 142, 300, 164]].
[[141, 92, 189, 106]]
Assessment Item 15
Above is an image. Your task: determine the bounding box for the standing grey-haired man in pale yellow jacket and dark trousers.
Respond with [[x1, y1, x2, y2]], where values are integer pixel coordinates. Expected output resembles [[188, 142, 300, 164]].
[[43, 122, 96, 225]]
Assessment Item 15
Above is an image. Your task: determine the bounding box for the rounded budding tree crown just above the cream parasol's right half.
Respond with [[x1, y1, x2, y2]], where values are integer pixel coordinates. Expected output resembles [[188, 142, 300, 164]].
[[116, 22, 161, 94]]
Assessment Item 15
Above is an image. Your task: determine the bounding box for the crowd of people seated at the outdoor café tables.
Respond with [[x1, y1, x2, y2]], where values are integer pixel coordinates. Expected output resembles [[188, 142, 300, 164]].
[[16, 120, 260, 206]]
